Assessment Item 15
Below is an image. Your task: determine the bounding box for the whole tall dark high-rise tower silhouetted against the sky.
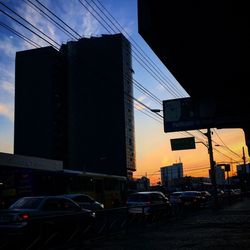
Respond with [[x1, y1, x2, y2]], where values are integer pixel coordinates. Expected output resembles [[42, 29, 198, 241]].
[[14, 34, 135, 176]]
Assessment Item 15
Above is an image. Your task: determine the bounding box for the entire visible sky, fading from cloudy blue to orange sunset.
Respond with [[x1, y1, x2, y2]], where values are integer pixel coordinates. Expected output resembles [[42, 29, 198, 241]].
[[0, 0, 249, 183]]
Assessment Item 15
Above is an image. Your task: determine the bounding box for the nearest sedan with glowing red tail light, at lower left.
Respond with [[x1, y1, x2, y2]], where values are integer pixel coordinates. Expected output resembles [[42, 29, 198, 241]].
[[0, 196, 95, 249]]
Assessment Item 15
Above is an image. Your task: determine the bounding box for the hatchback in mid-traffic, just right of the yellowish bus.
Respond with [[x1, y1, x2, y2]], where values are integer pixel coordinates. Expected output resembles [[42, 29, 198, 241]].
[[127, 191, 171, 216]]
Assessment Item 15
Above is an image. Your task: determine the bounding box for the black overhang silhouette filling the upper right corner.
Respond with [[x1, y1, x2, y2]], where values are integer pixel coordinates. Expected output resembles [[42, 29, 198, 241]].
[[138, 0, 250, 128]]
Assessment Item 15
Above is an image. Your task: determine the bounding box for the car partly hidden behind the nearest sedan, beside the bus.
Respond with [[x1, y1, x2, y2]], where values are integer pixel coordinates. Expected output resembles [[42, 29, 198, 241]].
[[63, 194, 104, 211]]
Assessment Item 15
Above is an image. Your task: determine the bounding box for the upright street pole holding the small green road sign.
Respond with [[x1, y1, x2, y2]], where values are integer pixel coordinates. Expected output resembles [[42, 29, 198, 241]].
[[206, 128, 218, 209]]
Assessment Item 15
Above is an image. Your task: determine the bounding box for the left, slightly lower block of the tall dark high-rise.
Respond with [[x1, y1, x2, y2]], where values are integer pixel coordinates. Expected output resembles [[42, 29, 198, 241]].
[[14, 47, 66, 160]]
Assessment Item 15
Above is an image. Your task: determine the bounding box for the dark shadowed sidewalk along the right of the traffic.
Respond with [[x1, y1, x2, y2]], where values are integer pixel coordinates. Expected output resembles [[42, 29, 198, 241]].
[[85, 198, 250, 250]]
